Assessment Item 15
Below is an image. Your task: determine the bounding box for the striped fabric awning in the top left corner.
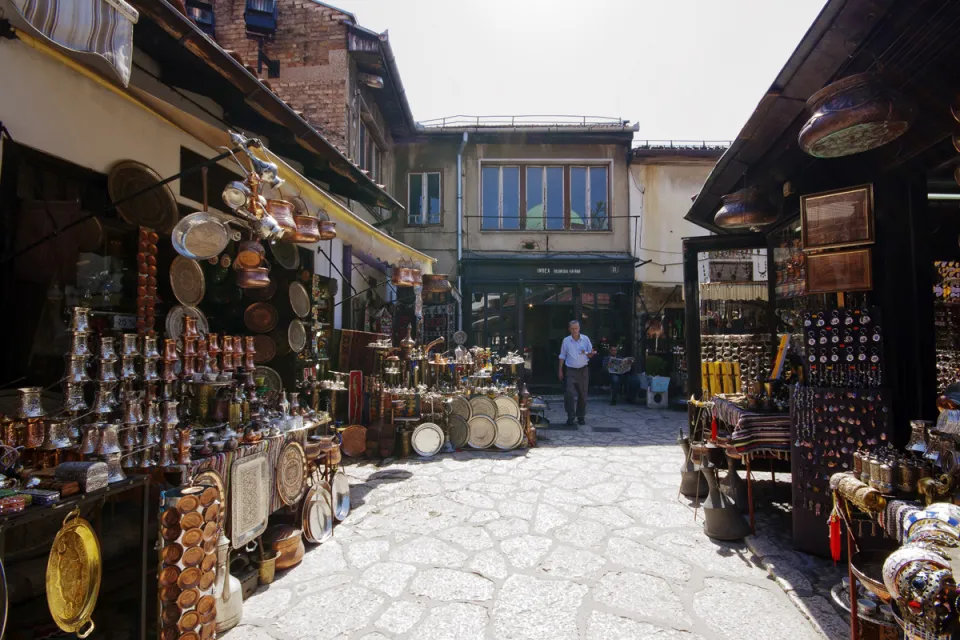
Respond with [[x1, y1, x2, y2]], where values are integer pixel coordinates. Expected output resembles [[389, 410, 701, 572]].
[[0, 0, 139, 86]]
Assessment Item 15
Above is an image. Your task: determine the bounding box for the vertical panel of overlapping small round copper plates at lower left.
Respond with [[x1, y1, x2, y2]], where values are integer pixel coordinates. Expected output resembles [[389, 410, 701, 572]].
[[157, 485, 221, 640]]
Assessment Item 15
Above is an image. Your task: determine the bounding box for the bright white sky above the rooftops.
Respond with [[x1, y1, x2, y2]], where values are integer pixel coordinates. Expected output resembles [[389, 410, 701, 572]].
[[327, 0, 825, 140]]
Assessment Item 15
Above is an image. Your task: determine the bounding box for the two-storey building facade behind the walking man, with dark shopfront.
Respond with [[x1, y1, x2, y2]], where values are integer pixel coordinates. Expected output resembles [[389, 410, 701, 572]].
[[391, 118, 635, 384]]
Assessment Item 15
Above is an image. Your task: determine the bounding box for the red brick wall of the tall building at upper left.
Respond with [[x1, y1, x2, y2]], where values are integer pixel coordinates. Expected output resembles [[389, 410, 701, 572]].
[[213, 0, 350, 153]]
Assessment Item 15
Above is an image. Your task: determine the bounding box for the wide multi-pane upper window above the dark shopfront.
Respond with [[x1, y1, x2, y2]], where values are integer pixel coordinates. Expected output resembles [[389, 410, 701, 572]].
[[480, 163, 610, 231]]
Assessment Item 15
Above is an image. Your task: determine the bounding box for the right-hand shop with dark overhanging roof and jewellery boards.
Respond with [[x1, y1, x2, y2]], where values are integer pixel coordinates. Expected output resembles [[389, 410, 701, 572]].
[[681, 2, 960, 639]]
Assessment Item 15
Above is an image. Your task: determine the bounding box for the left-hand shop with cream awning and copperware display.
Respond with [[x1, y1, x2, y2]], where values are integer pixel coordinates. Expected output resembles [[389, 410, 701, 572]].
[[0, 10, 496, 640]]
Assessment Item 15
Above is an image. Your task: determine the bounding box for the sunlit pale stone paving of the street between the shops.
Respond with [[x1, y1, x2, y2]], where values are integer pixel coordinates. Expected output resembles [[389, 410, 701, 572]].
[[227, 398, 822, 640]]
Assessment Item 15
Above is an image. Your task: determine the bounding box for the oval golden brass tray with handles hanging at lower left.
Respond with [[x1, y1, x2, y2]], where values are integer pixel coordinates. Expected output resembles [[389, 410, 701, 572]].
[[46, 509, 103, 638]]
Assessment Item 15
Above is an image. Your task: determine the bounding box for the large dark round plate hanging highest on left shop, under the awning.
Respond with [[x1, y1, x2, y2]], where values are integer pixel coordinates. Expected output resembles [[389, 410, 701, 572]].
[[107, 160, 179, 233]]
